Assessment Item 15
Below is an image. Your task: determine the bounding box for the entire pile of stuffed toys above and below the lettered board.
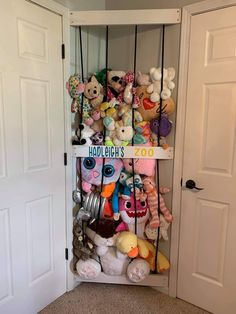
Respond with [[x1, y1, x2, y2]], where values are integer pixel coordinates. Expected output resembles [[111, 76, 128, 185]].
[[67, 68, 175, 282]]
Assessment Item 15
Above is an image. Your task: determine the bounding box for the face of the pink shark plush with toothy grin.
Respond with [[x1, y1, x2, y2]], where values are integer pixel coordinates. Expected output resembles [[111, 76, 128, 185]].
[[119, 193, 149, 224]]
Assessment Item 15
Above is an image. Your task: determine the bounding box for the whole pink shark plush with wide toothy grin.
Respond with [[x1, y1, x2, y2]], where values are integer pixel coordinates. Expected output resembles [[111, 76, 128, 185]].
[[116, 193, 149, 239]]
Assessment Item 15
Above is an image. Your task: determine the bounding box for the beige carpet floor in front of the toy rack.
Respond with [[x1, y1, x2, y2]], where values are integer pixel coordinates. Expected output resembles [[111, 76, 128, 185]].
[[40, 283, 208, 314]]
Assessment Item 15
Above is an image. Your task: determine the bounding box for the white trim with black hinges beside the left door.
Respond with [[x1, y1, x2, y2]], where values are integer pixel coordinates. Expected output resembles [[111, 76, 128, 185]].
[[26, 0, 76, 291]]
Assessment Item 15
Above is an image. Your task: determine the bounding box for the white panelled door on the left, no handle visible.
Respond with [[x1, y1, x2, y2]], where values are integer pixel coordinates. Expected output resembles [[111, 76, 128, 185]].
[[0, 0, 66, 314]]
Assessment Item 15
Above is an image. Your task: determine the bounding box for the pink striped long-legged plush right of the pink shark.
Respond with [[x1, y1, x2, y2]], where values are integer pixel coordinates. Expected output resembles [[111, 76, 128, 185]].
[[143, 177, 173, 228]]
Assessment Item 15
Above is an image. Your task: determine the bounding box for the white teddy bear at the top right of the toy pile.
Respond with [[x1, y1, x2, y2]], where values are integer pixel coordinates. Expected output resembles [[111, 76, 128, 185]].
[[147, 68, 175, 102]]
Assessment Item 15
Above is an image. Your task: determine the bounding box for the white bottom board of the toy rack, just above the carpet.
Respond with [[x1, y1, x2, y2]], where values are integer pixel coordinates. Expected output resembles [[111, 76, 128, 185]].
[[75, 273, 168, 287]]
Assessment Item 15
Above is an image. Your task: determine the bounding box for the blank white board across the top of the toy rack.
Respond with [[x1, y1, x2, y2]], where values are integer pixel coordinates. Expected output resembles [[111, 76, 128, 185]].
[[70, 9, 181, 26]]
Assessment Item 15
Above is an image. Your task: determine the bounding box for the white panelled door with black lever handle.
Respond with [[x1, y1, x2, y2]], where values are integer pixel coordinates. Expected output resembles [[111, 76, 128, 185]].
[[177, 7, 236, 314]]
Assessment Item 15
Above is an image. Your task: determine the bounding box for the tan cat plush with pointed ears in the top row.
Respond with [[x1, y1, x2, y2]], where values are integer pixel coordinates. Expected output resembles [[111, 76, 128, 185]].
[[84, 75, 104, 108]]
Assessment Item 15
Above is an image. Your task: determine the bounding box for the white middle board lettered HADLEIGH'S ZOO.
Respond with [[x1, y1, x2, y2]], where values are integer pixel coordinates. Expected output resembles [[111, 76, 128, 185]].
[[72, 145, 174, 159]]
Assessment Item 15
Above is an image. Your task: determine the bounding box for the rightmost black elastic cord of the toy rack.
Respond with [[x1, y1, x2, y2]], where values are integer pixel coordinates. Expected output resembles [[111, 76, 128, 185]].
[[154, 24, 165, 273]]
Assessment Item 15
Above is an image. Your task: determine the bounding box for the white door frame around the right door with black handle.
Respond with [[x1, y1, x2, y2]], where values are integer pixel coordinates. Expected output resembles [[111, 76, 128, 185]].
[[169, 0, 236, 297]]
